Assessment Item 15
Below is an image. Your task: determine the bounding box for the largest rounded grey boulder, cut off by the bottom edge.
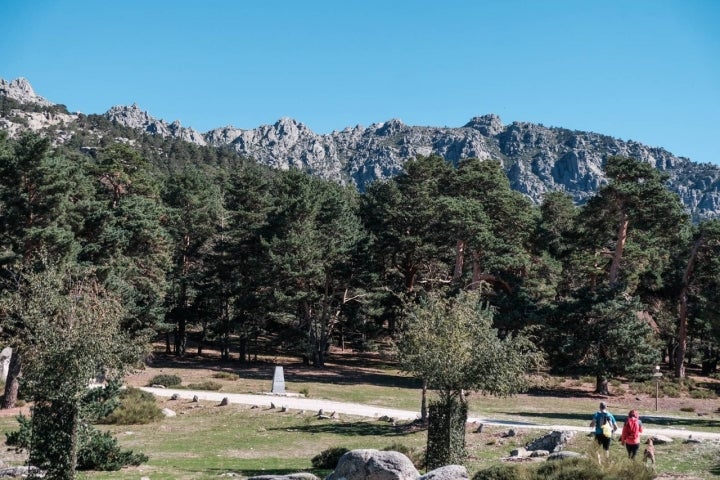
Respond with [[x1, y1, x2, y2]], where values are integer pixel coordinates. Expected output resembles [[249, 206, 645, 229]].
[[326, 449, 420, 480]]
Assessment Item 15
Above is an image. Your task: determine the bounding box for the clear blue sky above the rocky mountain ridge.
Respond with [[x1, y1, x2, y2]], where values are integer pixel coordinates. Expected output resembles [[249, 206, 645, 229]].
[[0, 0, 720, 164]]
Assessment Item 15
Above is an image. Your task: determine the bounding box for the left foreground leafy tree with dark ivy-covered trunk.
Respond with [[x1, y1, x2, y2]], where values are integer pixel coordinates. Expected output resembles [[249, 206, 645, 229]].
[[0, 265, 139, 479]]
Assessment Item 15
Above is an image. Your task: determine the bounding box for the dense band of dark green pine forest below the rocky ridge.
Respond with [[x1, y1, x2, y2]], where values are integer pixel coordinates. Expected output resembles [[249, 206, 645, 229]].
[[0, 129, 720, 404]]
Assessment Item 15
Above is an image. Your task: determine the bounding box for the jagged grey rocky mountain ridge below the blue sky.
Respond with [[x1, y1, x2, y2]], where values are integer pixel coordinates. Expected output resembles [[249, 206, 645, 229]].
[[0, 79, 720, 219]]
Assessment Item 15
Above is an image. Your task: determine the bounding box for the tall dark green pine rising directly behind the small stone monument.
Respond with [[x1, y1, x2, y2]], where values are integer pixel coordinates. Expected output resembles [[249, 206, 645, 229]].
[[264, 170, 363, 367]]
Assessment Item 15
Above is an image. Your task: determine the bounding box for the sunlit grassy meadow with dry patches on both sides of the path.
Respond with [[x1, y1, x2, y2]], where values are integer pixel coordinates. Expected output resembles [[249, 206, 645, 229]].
[[0, 355, 720, 480]]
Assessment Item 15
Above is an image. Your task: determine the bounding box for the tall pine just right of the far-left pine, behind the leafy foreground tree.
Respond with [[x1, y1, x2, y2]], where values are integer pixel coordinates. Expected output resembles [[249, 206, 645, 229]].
[[91, 144, 172, 338]]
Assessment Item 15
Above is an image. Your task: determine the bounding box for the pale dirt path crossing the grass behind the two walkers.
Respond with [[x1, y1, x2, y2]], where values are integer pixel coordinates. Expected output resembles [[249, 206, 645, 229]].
[[141, 387, 720, 440]]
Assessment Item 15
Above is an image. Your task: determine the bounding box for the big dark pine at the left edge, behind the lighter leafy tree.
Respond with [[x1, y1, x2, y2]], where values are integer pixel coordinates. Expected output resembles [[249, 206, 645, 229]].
[[0, 134, 98, 408]]
